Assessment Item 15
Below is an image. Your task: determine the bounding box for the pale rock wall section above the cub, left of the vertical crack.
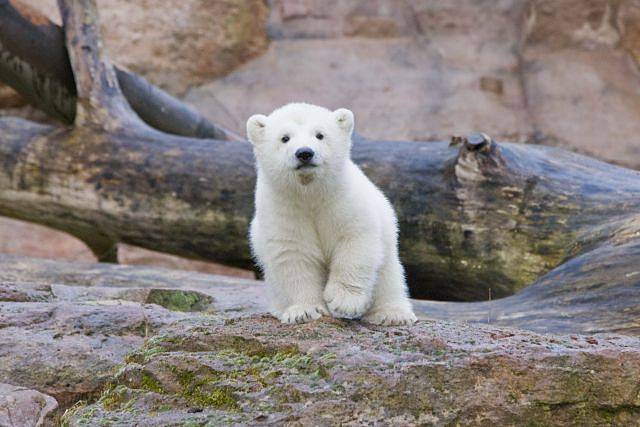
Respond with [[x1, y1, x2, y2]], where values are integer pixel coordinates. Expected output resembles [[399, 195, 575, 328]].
[[186, 1, 533, 144]]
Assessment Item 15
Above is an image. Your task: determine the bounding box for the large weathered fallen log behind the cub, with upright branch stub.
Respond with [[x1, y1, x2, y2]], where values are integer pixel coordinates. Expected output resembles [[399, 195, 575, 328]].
[[0, 0, 640, 300]]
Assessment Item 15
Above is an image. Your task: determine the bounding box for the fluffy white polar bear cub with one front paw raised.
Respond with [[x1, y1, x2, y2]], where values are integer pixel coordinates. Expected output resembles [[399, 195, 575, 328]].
[[247, 103, 416, 325]]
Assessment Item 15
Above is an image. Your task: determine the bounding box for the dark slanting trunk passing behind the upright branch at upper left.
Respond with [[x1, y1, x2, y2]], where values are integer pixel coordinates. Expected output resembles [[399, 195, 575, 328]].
[[0, 0, 240, 140]]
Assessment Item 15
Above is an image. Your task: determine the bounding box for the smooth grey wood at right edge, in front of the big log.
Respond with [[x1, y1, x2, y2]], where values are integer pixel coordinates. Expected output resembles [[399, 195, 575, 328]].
[[414, 239, 640, 336]]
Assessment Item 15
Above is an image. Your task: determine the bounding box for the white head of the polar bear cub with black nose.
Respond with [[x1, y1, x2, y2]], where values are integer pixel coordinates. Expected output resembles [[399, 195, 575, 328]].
[[247, 103, 354, 186]]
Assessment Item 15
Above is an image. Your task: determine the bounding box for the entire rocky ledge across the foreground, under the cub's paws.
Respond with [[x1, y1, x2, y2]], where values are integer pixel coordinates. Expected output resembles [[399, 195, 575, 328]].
[[0, 256, 640, 426]]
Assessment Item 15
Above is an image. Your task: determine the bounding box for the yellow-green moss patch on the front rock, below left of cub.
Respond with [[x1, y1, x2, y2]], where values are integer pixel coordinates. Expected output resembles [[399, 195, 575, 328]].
[[90, 335, 336, 419]]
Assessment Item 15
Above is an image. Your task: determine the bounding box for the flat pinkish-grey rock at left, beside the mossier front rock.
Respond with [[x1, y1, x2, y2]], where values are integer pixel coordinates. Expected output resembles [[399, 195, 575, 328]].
[[0, 254, 257, 414]]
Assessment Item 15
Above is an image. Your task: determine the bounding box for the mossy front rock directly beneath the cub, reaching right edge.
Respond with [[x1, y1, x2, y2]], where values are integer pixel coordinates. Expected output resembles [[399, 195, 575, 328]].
[[66, 315, 640, 426]]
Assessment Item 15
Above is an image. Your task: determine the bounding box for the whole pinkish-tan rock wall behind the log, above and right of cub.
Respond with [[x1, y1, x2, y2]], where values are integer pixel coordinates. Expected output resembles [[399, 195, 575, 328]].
[[186, 0, 640, 168]]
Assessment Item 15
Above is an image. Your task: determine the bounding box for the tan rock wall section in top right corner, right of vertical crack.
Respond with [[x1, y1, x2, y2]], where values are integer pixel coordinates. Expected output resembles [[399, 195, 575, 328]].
[[521, 0, 640, 168]]
